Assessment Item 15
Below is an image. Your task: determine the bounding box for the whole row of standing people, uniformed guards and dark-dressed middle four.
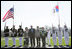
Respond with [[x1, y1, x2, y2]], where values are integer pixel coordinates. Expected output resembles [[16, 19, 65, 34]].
[[4, 25, 69, 47]]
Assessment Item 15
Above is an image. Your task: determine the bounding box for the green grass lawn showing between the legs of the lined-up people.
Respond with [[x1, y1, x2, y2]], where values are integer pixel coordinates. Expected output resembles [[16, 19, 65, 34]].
[[1, 37, 71, 46]]
